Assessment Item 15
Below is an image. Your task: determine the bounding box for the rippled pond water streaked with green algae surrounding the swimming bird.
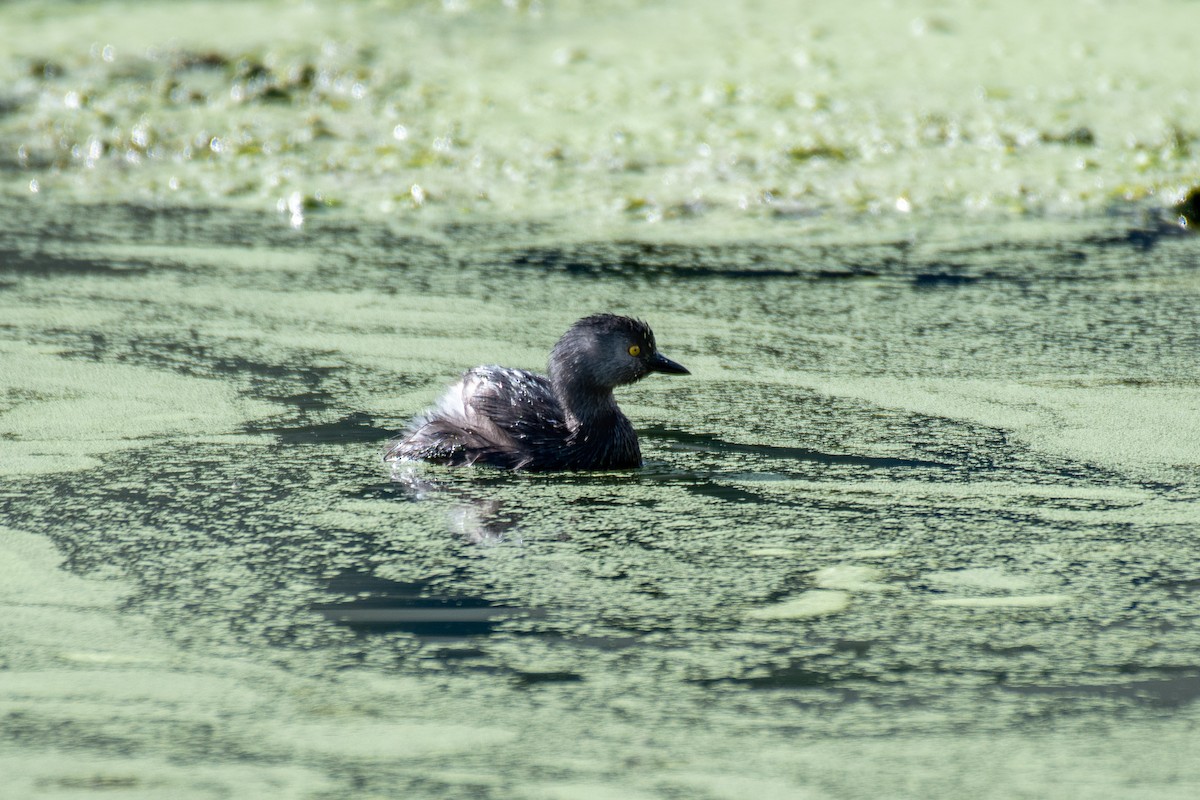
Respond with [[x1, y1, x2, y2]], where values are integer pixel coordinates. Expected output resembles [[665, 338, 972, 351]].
[[0, 201, 1200, 798]]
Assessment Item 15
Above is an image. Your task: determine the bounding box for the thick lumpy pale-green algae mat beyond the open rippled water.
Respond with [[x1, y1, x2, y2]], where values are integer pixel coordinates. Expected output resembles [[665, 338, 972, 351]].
[[0, 0, 1200, 233]]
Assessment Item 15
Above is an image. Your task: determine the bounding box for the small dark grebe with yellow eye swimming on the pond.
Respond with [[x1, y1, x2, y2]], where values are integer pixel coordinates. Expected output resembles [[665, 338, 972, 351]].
[[384, 314, 689, 471]]
